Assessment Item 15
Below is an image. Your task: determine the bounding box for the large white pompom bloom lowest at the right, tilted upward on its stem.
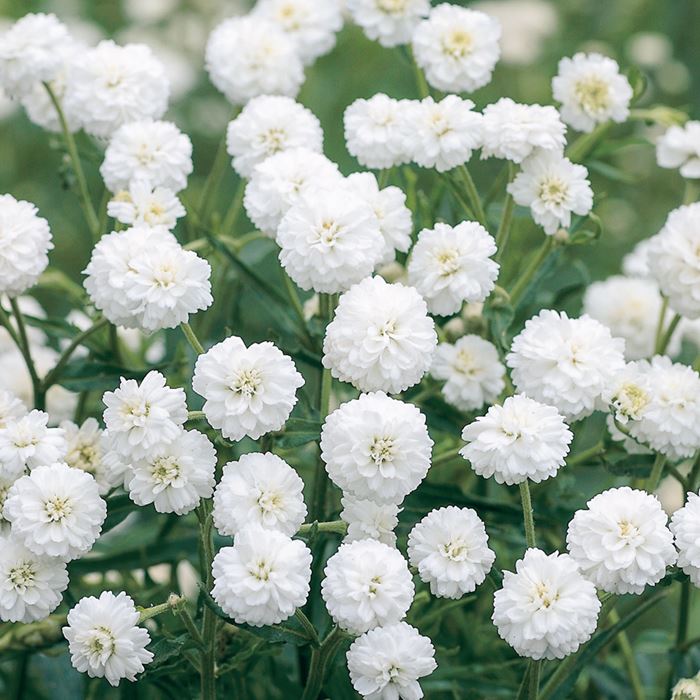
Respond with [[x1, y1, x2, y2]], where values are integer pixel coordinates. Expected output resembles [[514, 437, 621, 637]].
[[492, 549, 600, 659]]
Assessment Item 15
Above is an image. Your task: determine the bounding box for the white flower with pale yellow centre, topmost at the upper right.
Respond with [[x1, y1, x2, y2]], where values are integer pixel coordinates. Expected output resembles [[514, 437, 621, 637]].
[[552, 53, 632, 131]]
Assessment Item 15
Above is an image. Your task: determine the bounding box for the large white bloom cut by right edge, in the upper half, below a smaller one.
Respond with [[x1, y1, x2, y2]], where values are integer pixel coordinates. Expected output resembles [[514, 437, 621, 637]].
[[648, 202, 700, 319]]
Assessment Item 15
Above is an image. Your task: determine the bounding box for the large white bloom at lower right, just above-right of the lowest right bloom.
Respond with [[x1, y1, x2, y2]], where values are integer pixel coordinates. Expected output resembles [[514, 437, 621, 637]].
[[566, 486, 677, 595]]
